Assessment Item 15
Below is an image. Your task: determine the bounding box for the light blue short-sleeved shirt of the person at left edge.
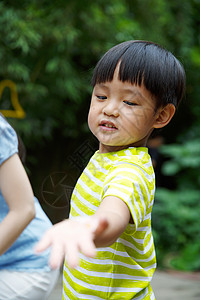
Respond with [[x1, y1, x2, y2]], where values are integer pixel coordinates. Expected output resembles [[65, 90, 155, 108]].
[[0, 115, 52, 272]]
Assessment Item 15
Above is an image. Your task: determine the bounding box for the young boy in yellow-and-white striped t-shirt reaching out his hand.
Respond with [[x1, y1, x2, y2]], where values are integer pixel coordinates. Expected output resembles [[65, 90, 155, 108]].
[[36, 41, 185, 300]]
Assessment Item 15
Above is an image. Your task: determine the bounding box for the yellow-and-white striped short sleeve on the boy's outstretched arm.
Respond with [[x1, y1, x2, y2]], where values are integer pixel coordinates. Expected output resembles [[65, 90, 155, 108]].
[[102, 163, 150, 231]]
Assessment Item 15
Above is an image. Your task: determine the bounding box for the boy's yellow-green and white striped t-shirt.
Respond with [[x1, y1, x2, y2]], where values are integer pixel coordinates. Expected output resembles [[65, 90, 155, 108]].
[[62, 147, 156, 300]]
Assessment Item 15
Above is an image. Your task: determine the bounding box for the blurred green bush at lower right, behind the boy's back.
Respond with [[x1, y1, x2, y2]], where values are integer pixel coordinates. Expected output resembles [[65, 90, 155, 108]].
[[153, 136, 200, 271]]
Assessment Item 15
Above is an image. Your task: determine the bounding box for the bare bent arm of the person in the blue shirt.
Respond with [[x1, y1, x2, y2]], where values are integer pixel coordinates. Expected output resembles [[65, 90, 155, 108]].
[[0, 154, 35, 255]]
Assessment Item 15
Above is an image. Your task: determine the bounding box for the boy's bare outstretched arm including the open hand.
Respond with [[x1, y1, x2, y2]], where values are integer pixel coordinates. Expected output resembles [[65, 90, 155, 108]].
[[35, 196, 130, 268]]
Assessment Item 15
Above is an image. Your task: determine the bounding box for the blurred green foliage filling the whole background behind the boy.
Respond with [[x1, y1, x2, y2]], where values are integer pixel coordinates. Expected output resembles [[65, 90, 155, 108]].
[[0, 0, 200, 270]]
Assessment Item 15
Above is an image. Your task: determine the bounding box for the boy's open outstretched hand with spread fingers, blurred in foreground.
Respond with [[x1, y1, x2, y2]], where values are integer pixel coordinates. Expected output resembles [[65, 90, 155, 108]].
[[35, 216, 108, 269]]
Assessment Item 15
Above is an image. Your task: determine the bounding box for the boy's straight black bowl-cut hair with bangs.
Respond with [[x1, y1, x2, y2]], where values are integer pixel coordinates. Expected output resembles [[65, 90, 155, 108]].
[[91, 41, 185, 107]]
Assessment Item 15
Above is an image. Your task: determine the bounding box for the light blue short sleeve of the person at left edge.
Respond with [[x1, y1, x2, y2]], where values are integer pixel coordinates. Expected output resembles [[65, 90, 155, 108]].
[[0, 115, 18, 165]]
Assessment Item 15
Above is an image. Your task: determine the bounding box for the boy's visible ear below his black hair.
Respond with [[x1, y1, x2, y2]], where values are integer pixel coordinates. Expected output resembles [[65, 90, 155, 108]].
[[154, 103, 176, 128]]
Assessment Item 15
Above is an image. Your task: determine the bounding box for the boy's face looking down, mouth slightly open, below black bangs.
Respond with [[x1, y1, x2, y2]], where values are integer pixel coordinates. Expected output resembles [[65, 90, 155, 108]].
[[88, 67, 160, 153]]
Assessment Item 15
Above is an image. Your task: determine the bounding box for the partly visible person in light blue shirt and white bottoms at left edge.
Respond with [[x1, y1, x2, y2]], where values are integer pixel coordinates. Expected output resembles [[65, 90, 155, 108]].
[[0, 115, 59, 300]]
